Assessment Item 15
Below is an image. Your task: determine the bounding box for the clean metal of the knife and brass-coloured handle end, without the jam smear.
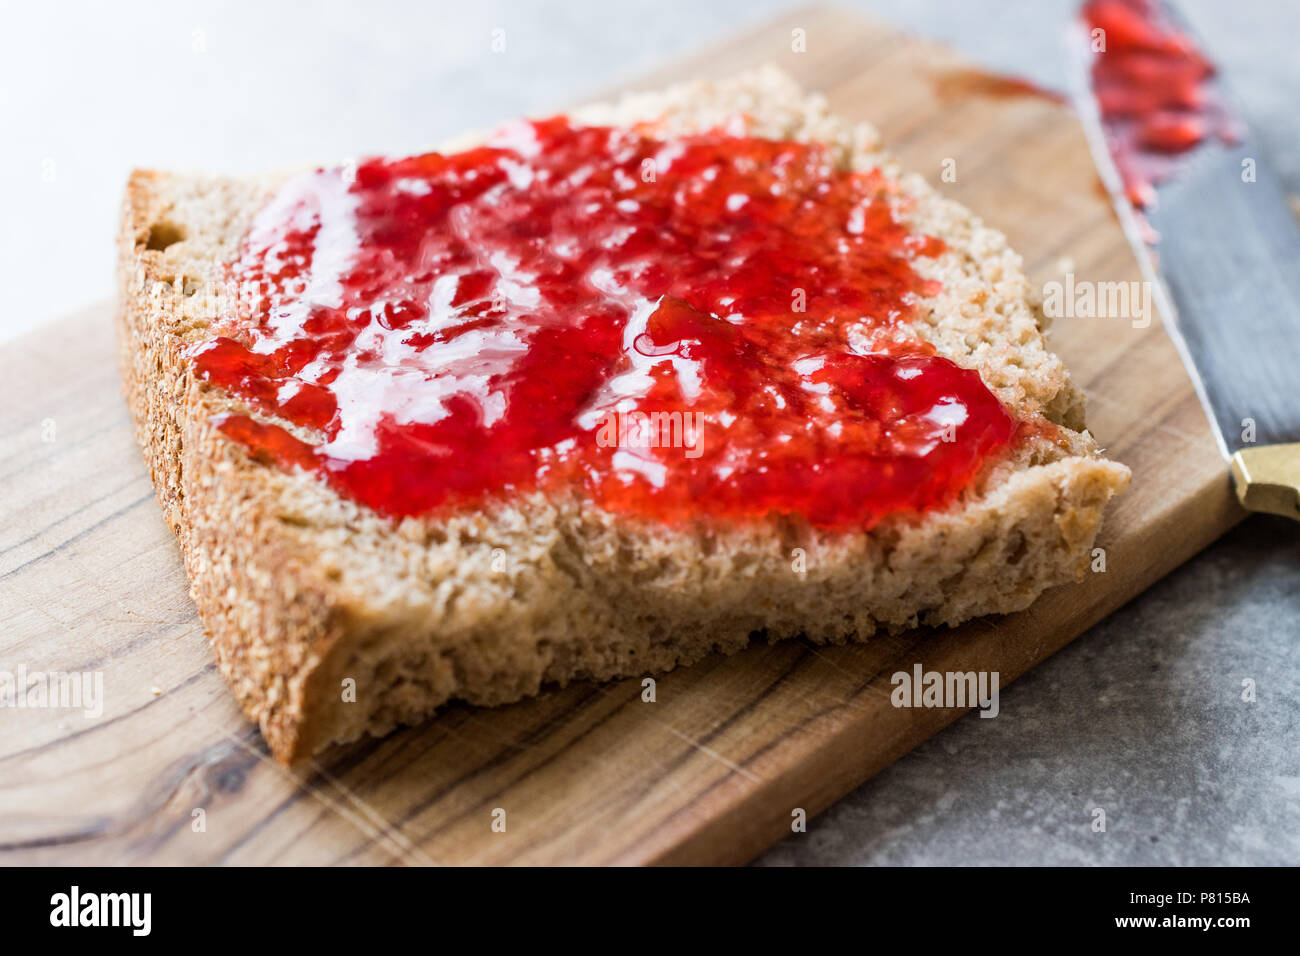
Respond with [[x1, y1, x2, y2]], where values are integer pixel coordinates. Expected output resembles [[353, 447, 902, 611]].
[[1071, 0, 1300, 518]]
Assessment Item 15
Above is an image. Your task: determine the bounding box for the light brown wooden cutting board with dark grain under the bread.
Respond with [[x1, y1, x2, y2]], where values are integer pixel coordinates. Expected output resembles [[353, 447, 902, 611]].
[[0, 9, 1242, 864]]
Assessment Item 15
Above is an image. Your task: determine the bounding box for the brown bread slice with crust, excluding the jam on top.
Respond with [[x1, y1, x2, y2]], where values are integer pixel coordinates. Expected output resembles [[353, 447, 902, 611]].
[[120, 70, 1128, 762]]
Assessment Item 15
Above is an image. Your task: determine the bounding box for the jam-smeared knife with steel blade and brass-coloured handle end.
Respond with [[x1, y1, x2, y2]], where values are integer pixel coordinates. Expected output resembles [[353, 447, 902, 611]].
[[1070, 0, 1300, 520]]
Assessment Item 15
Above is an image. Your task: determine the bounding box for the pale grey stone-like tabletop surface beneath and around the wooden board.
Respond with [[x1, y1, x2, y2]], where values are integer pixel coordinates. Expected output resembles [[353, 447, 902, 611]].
[[0, 0, 1300, 865]]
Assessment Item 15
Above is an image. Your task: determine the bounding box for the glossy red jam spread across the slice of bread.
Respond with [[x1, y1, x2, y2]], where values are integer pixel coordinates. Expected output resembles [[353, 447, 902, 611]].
[[191, 118, 1017, 528]]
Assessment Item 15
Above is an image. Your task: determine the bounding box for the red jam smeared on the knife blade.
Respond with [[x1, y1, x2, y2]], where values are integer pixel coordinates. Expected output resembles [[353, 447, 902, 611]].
[[1083, 0, 1234, 208]]
